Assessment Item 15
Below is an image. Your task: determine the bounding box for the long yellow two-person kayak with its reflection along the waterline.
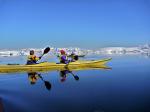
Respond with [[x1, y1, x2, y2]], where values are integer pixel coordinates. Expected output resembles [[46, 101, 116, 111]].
[[0, 58, 111, 73]]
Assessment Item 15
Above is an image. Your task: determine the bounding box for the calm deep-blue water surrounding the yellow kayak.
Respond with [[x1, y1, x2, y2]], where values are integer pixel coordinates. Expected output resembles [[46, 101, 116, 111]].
[[0, 55, 150, 112]]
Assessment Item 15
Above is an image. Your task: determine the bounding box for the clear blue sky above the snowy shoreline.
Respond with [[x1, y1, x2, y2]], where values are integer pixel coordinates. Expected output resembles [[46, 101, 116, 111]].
[[0, 0, 150, 48]]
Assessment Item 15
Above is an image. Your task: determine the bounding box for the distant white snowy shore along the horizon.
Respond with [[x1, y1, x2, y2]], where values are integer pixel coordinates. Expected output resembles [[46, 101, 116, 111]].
[[0, 44, 150, 57]]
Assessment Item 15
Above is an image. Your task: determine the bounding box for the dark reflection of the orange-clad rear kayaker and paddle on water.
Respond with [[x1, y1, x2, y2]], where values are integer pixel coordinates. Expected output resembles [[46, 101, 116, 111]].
[[28, 72, 52, 90]]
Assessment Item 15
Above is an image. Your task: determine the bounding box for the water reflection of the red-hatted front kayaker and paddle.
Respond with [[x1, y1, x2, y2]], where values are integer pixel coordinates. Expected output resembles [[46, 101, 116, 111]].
[[60, 70, 79, 82]]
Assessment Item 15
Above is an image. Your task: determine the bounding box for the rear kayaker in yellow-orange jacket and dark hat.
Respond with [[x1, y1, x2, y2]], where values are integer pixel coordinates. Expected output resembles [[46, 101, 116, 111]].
[[27, 50, 41, 65]]
